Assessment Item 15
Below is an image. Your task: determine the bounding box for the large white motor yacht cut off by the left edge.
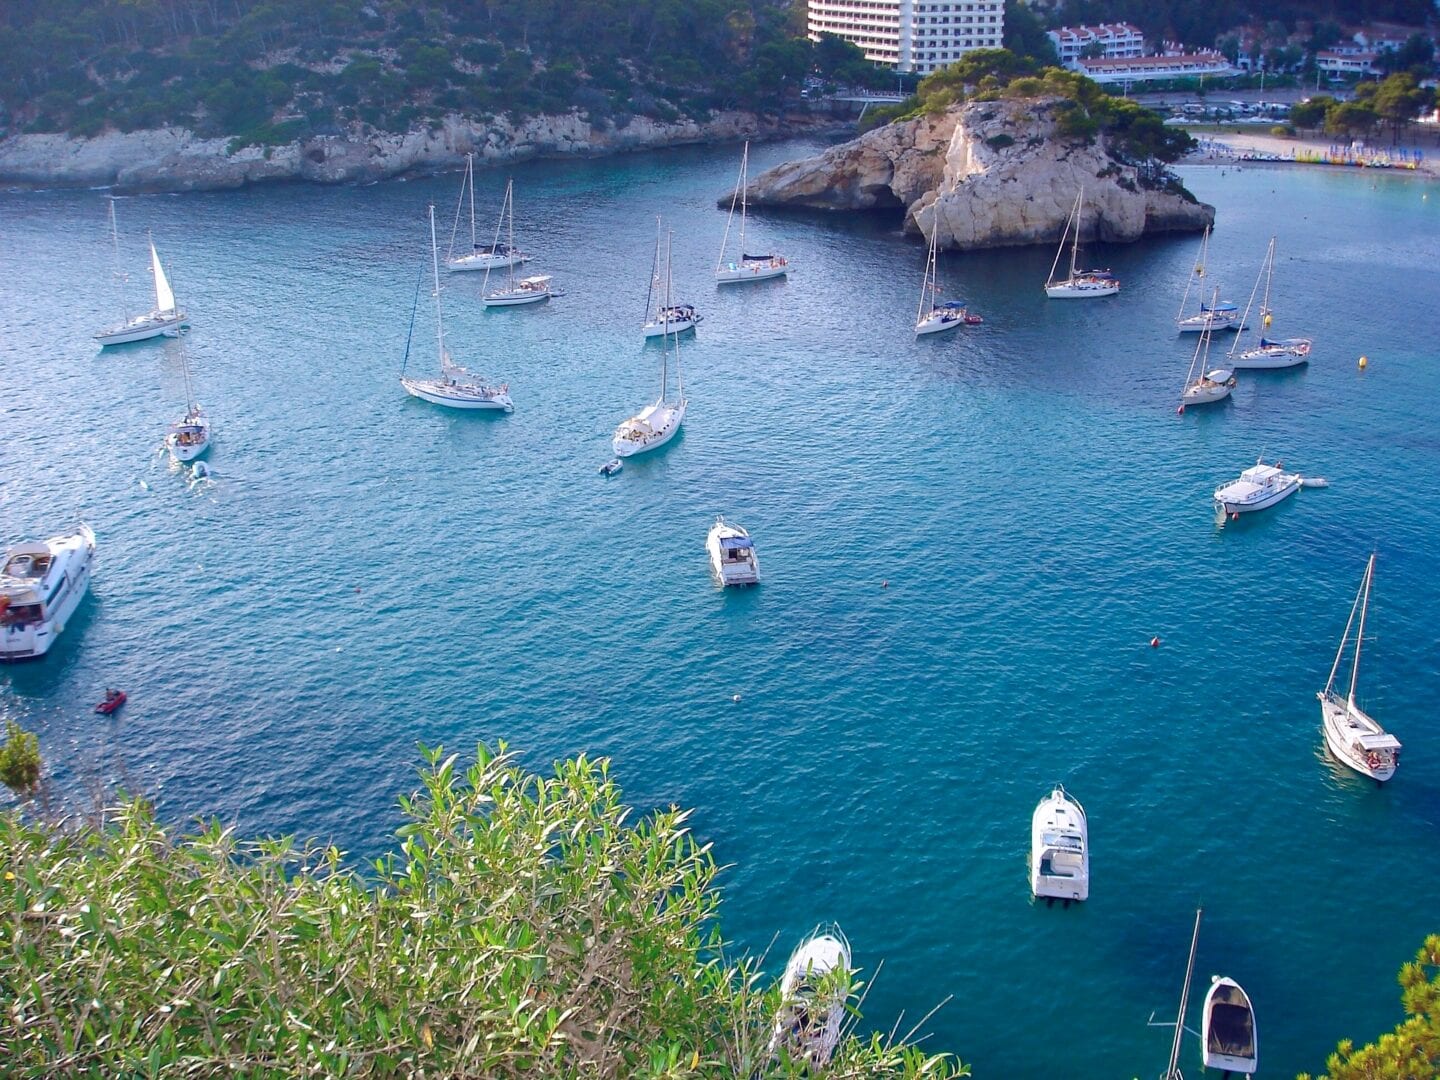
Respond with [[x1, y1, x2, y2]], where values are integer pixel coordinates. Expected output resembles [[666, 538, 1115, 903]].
[[0, 526, 95, 660]]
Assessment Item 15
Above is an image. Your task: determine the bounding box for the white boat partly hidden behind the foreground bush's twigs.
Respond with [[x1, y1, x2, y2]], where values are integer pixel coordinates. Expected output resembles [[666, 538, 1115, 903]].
[[770, 924, 851, 1068]]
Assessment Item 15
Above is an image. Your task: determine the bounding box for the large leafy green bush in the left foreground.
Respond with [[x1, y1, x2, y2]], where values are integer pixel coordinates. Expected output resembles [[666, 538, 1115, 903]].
[[0, 746, 968, 1077]]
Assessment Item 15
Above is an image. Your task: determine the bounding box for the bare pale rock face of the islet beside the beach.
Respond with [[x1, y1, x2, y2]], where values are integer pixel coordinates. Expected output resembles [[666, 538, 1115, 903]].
[[723, 99, 1215, 249]]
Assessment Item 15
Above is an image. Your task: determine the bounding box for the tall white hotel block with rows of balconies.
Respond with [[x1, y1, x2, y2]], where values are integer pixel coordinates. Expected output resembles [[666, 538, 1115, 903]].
[[809, 0, 1005, 75]]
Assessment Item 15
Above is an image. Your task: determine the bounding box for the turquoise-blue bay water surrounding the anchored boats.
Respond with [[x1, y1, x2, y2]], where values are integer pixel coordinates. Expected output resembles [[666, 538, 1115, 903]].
[[0, 143, 1440, 1080]]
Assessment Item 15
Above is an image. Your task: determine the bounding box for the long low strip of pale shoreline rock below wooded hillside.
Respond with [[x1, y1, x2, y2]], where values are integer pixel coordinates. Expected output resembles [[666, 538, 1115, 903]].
[[0, 112, 827, 192]]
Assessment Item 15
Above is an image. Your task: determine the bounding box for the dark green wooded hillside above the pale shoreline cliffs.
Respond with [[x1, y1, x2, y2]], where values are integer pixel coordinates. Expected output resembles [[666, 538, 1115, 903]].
[[0, 0, 873, 143]]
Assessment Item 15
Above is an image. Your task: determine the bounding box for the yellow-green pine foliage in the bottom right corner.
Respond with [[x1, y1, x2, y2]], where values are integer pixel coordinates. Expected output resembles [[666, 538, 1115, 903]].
[[1299, 935, 1440, 1080]]
